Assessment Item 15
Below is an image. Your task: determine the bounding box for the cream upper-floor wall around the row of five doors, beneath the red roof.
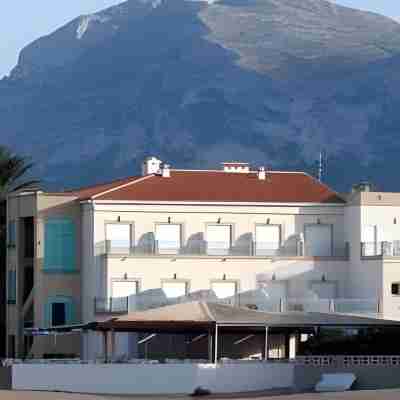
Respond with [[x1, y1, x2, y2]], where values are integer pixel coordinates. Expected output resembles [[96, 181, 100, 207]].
[[94, 204, 344, 256]]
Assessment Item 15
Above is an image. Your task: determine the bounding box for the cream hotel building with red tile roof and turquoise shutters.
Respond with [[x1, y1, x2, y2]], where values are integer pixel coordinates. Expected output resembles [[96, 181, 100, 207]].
[[7, 158, 400, 357]]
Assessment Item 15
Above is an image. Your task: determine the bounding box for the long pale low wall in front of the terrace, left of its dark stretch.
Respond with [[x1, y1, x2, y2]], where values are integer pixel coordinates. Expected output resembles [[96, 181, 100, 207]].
[[12, 362, 294, 394]]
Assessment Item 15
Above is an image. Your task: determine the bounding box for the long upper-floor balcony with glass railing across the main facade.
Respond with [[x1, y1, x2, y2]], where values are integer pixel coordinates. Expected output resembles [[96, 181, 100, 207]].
[[103, 240, 349, 258]]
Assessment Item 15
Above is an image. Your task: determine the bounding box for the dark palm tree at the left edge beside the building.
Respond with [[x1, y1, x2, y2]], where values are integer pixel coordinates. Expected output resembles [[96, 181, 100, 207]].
[[0, 146, 38, 356]]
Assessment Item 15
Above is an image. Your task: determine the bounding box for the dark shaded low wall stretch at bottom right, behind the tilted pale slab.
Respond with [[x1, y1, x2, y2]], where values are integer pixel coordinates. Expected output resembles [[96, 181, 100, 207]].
[[294, 365, 400, 390]]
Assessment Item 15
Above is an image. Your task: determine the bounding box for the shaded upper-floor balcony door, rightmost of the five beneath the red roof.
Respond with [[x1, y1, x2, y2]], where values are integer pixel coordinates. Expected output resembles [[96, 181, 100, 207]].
[[304, 224, 332, 257]]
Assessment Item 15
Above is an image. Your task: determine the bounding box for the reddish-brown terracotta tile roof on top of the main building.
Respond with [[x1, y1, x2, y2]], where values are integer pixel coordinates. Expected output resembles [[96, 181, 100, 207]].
[[90, 170, 345, 203]]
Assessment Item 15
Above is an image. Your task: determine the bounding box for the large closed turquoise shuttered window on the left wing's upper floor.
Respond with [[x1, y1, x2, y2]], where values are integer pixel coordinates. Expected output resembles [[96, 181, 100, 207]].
[[44, 219, 76, 272]]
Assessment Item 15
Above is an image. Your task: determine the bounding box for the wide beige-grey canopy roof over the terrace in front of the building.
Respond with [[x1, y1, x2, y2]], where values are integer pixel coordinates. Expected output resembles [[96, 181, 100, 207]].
[[95, 302, 400, 333]]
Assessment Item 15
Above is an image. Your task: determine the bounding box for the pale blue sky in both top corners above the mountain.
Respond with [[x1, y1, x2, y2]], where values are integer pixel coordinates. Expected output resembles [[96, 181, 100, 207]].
[[0, 0, 400, 78]]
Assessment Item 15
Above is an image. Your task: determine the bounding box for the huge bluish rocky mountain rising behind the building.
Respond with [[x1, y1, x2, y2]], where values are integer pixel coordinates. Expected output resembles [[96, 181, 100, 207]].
[[0, 0, 400, 190]]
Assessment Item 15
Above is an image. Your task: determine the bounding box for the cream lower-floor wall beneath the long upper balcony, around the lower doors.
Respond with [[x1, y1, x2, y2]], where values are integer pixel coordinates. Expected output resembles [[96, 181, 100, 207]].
[[107, 257, 348, 298]]
